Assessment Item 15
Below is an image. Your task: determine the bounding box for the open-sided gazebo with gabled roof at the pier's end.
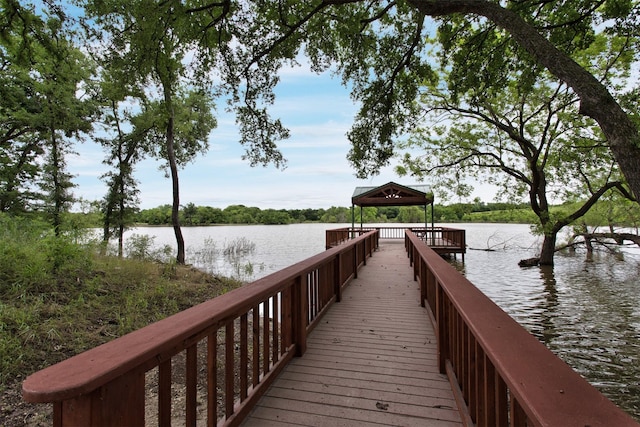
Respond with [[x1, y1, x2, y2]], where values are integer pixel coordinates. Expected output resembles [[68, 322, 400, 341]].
[[351, 182, 433, 228]]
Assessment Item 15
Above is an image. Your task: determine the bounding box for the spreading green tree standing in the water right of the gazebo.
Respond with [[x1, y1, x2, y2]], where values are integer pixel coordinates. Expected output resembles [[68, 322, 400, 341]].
[[398, 33, 633, 265]]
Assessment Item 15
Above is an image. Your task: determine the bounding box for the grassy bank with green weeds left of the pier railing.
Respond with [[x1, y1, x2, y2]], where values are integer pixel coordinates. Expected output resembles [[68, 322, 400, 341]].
[[0, 217, 241, 426]]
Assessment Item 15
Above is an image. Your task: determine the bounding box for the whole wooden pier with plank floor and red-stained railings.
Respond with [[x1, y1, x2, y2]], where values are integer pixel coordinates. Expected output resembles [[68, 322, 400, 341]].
[[22, 229, 640, 427]]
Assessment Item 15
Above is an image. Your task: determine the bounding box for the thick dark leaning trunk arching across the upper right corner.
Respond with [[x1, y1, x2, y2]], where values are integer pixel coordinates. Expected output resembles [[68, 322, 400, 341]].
[[409, 0, 640, 203]]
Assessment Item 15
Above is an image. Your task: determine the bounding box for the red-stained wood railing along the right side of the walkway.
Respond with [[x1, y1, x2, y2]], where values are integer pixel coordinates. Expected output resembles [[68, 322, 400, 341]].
[[405, 230, 638, 427]]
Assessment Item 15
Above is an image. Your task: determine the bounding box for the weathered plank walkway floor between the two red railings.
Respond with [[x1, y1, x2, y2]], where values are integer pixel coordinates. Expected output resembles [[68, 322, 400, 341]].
[[243, 241, 461, 427]]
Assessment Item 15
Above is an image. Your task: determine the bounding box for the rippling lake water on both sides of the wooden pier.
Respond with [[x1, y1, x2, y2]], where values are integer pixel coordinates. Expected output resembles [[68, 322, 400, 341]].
[[125, 224, 640, 420]]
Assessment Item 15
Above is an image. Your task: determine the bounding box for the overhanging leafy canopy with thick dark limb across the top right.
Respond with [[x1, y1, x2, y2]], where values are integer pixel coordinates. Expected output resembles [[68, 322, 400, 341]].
[[230, 0, 640, 204]]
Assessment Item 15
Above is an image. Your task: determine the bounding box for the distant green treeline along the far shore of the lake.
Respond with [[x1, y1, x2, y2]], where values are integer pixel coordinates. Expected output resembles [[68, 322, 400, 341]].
[[134, 202, 535, 226]]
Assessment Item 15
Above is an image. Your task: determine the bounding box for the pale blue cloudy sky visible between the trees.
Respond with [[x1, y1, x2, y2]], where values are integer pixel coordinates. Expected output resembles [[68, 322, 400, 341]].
[[68, 66, 493, 209]]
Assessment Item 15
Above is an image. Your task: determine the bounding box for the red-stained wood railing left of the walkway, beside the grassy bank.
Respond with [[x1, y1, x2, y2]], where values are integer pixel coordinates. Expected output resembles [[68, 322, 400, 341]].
[[22, 231, 378, 426]]
